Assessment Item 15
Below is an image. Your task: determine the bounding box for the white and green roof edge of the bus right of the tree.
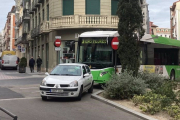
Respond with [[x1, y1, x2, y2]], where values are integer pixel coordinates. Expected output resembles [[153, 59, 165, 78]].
[[140, 34, 180, 47]]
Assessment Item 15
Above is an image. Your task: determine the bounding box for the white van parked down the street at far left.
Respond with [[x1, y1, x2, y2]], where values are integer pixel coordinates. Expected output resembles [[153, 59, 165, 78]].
[[1, 55, 18, 70]]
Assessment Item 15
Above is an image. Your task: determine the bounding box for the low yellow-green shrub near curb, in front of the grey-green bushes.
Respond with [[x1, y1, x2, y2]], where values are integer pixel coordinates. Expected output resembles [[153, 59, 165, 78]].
[[132, 92, 173, 115]]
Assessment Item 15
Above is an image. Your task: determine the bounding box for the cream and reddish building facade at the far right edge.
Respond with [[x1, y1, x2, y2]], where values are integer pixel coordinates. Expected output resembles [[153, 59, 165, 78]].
[[170, 1, 180, 40]]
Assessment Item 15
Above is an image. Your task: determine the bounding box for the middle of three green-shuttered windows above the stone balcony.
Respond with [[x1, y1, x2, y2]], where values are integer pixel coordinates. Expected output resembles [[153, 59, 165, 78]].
[[86, 0, 100, 15]]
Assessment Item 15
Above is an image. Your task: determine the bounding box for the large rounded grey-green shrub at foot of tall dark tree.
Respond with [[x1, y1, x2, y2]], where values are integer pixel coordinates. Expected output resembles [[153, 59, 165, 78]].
[[103, 71, 146, 99]]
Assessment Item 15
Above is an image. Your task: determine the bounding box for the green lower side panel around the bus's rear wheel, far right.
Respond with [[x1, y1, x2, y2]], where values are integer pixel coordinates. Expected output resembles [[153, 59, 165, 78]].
[[165, 65, 180, 79]]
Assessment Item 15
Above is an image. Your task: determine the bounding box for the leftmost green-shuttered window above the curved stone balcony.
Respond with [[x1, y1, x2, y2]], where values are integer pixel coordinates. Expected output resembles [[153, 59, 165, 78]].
[[63, 0, 74, 15]]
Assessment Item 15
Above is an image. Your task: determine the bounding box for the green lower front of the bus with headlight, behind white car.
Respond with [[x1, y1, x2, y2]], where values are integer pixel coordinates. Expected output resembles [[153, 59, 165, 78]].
[[91, 67, 115, 83]]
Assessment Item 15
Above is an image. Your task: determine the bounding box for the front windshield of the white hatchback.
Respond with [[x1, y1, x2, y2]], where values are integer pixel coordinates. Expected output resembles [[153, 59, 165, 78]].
[[50, 65, 81, 76]]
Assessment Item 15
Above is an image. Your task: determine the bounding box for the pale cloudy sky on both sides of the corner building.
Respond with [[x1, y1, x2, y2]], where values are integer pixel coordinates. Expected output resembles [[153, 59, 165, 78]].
[[0, 0, 177, 30]]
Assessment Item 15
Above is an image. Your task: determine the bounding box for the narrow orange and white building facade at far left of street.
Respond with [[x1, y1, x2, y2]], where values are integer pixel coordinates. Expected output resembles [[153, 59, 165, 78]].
[[3, 6, 16, 51]]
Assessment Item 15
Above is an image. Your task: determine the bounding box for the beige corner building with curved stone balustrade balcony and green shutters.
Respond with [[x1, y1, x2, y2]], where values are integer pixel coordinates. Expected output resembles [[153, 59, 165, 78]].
[[15, 0, 149, 71]]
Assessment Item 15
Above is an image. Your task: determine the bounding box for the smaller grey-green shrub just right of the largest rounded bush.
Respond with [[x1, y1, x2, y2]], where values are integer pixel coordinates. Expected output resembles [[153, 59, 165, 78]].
[[138, 71, 165, 90]]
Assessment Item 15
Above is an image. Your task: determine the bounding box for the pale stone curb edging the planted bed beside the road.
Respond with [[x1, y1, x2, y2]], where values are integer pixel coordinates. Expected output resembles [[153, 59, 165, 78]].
[[91, 90, 158, 120]]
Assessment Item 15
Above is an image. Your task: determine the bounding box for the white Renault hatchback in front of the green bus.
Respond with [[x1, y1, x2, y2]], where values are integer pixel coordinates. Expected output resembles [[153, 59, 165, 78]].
[[40, 63, 94, 100]]
